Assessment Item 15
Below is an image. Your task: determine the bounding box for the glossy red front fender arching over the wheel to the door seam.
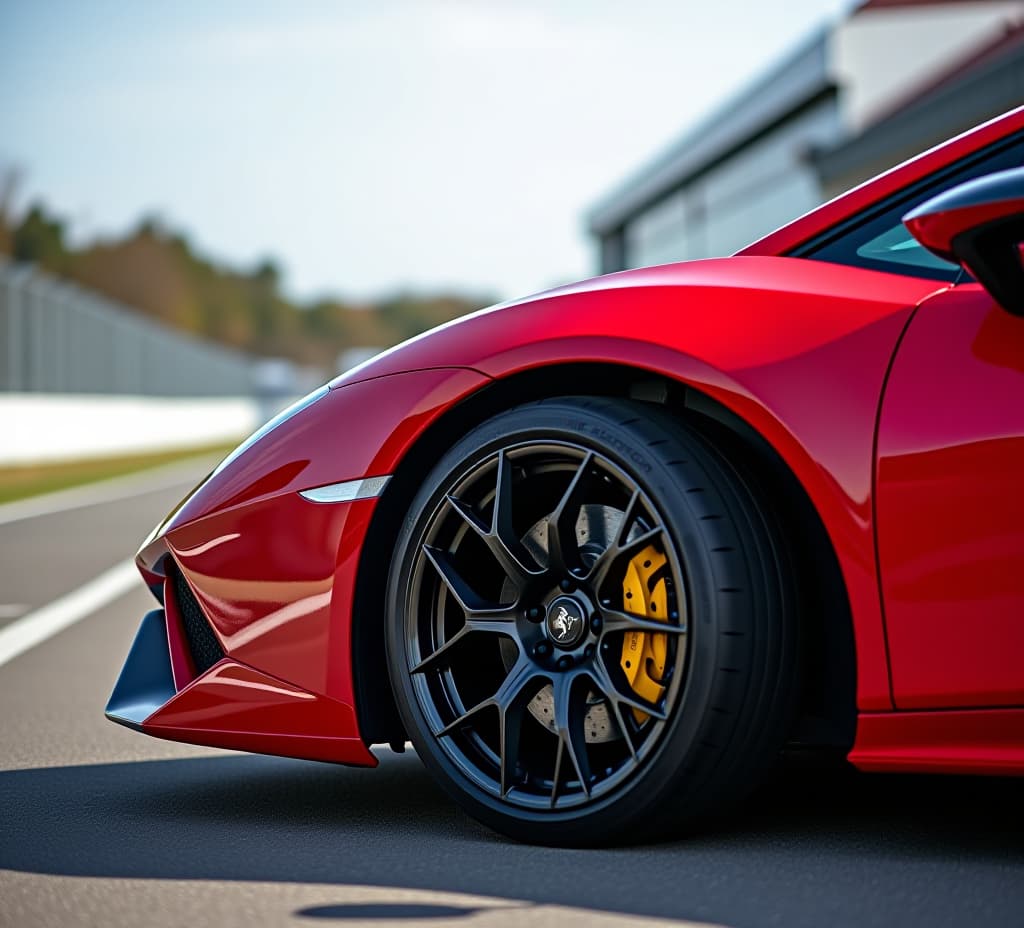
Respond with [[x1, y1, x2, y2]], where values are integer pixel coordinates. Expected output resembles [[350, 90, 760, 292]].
[[339, 257, 941, 710]]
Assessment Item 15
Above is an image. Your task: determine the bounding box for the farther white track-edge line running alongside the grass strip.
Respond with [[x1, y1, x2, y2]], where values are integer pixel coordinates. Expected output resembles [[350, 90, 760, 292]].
[[0, 455, 222, 525]]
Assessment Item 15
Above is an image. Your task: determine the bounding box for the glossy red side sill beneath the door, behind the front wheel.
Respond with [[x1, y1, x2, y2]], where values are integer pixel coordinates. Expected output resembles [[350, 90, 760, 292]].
[[850, 709, 1024, 774]]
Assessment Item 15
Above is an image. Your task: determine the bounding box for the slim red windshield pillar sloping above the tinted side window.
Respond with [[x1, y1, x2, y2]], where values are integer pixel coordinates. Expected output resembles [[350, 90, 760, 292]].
[[739, 107, 1024, 255]]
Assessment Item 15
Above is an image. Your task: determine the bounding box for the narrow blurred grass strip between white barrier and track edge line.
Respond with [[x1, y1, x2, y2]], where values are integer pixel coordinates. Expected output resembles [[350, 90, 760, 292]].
[[0, 441, 238, 503]]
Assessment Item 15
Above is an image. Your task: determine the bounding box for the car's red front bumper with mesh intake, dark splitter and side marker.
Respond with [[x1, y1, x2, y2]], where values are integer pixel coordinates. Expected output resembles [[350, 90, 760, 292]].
[[108, 369, 487, 765]]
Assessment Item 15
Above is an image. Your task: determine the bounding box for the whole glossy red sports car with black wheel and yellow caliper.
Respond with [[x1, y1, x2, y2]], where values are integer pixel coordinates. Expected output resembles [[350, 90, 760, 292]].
[[106, 108, 1024, 845]]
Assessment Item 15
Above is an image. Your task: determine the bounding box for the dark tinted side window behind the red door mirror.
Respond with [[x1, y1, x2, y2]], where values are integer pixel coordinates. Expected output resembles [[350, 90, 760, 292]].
[[791, 133, 1024, 282]]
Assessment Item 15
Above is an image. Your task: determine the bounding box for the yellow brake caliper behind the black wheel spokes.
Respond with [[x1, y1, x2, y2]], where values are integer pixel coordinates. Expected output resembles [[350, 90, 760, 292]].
[[622, 545, 669, 724]]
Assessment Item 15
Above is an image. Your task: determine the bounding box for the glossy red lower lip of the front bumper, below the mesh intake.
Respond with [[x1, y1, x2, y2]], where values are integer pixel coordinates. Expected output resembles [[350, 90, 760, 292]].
[[142, 660, 377, 766]]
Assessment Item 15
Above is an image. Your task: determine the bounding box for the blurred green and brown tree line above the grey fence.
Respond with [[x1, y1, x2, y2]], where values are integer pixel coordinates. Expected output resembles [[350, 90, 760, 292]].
[[0, 198, 493, 370]]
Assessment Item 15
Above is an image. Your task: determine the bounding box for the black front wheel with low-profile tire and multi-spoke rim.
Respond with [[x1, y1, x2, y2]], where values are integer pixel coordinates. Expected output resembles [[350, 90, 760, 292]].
[[387, 397, 798, 846]]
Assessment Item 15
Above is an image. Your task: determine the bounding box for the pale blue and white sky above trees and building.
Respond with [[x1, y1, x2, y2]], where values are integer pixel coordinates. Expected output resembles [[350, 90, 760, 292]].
[[0, 0, 851, 299]]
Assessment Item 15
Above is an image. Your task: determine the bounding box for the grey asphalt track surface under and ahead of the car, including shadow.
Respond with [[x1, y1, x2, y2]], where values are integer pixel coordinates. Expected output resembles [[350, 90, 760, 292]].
[[0, 458, 1024, 928]]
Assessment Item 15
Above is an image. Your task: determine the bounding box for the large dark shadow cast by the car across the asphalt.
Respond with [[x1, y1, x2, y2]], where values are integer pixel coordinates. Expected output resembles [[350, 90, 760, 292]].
[[0, 754, 1024, 928]]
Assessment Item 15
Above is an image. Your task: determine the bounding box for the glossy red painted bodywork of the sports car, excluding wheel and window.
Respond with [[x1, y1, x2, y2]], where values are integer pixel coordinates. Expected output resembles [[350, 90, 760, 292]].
[[108, 108, 1024, 773]]
